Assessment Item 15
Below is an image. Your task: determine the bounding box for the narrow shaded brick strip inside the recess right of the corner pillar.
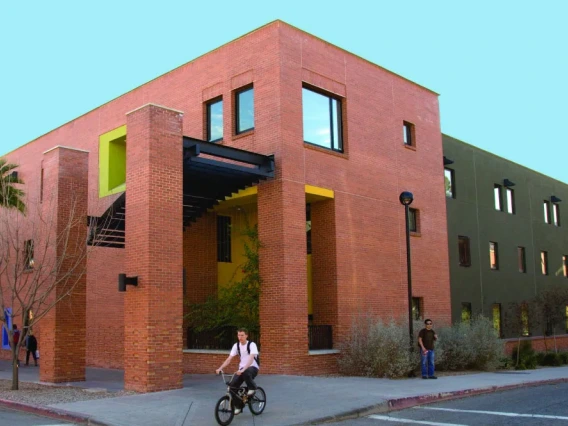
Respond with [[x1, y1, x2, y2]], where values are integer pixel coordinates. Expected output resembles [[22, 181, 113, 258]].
[[311, 200, 338, 346]]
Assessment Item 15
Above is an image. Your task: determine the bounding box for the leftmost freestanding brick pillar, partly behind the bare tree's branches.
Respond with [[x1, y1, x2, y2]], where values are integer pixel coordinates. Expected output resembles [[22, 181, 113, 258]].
[[40, 146, 89, 383]]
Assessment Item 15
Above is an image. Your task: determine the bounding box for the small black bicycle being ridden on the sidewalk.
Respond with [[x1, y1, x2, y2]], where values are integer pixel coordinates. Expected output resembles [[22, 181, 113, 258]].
[[215, 370, 266, 426]]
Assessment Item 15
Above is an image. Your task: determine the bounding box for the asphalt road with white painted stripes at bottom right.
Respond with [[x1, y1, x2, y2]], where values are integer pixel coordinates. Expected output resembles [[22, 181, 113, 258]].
[[326, 383, 568, 426]]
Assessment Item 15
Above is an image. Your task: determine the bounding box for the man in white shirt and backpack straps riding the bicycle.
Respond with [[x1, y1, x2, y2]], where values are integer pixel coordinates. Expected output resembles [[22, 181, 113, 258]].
[[215, 328, 259, 414]]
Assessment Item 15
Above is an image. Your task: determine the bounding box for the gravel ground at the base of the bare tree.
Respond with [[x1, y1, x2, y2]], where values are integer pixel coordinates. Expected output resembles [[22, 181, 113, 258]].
[[0, 379, 135, 405]]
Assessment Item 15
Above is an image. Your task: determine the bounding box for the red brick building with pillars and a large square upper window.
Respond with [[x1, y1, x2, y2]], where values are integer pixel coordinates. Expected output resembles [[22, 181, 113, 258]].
[[2, 21, 450, 391]]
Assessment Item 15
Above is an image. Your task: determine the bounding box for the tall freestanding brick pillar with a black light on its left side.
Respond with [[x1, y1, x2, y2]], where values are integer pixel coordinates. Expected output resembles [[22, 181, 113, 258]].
[[124, 104, 183, 392]]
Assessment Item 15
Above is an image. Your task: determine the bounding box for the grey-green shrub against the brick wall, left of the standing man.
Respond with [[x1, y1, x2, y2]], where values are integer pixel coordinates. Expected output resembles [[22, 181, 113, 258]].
[[338, 317, 418, 378]]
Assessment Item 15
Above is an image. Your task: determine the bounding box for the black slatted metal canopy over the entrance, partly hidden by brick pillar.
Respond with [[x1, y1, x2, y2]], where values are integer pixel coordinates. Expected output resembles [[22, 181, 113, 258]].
[[87, 136, 274, 248]]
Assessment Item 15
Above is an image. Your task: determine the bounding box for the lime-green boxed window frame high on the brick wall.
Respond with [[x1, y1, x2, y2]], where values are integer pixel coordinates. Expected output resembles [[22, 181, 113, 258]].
[[99, 126, 126, 197]]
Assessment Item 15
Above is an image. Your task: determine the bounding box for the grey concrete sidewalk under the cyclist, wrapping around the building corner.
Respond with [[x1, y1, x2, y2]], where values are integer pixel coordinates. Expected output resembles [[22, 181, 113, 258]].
[[0, 361, 568, 426]]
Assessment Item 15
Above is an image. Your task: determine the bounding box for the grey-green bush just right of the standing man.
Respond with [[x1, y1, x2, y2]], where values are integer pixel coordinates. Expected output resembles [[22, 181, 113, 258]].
[[436, 316, 504, 370]]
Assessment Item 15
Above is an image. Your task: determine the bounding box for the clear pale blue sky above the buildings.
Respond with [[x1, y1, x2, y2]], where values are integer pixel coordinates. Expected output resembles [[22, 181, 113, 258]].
[[0, 0, 568, 183]]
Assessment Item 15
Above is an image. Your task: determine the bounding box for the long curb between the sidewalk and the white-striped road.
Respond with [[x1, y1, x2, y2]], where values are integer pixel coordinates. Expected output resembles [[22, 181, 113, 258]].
[[293, 378, 568, 426]]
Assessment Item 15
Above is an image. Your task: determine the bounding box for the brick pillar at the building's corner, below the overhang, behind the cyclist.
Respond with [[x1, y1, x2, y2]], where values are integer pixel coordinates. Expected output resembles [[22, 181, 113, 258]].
[[258, 181, 308, 374]]
